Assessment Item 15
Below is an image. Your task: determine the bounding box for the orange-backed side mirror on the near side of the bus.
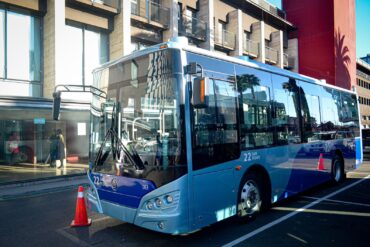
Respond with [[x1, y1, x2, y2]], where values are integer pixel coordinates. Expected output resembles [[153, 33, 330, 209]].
[[193, 77, 209, 109]]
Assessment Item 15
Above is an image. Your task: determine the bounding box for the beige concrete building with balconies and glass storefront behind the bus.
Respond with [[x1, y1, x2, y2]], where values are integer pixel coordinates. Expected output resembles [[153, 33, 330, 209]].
[[0, 0, 298, 181]]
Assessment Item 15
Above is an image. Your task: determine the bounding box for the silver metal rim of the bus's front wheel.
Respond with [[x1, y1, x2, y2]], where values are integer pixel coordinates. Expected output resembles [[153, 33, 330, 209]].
[[240, 180, 261, 215]]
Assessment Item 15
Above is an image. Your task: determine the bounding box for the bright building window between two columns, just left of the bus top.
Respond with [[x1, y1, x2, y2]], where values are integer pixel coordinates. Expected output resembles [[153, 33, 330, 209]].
[[62, 25, 109, 85]]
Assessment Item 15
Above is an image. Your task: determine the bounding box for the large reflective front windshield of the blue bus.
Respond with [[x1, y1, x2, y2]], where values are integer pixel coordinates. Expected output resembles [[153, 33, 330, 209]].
[[90, 50, 186, 186]]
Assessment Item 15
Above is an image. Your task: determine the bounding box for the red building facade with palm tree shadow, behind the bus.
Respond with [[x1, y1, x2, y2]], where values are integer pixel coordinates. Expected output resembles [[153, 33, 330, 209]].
[[282, 0, 356, 89]]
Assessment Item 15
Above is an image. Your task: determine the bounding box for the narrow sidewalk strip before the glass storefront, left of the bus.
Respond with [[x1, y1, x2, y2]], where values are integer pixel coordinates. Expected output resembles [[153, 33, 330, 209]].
[[0, 174, 88, 201]]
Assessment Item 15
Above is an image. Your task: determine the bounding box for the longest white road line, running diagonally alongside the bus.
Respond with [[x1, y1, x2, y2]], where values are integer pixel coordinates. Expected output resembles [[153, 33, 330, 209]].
[[223, 175, 370, 247]]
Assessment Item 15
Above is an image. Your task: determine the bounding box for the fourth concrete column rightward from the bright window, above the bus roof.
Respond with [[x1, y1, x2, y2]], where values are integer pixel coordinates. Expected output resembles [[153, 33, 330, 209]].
[[227, 9, 244, 56]]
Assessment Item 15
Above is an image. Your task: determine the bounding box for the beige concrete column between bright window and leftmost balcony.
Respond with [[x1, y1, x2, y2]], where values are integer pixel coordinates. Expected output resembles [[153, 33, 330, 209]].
[[109, 0, 131, 60]]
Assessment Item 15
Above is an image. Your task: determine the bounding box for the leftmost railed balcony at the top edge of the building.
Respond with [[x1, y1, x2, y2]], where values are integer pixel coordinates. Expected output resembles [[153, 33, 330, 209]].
[[131, 0, 170, 29]]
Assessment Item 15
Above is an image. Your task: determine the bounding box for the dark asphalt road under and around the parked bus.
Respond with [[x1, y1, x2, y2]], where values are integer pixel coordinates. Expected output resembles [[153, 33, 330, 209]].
[[0, 162, 370, 247]]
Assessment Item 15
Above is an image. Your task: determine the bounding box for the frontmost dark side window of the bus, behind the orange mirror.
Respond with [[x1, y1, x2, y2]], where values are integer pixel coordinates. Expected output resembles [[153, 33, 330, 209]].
[[193, 75, 239, 169]]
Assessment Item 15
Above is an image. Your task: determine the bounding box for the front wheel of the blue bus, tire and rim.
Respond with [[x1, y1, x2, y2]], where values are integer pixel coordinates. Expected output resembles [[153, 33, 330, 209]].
[[237, 173, 262, 220]]
